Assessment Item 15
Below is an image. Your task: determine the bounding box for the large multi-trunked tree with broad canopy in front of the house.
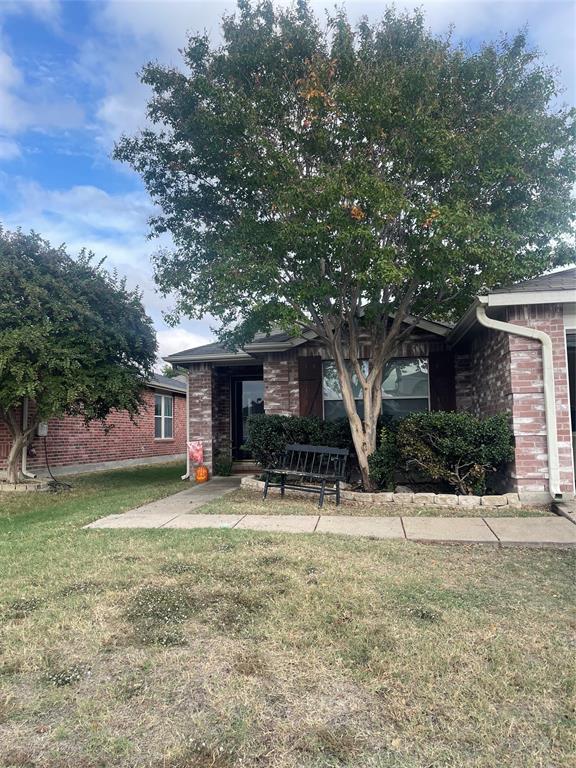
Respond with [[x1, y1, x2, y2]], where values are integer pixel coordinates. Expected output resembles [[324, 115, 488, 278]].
[[116, 0, 575, 484]]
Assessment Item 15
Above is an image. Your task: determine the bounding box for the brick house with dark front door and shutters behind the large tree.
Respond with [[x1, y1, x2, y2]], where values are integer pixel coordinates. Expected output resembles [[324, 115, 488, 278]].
[[166, 269, 576, 502]]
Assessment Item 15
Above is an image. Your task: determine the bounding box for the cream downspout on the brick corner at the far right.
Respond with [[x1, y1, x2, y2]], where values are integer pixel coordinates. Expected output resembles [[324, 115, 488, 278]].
[[476, 296, 562, 499]]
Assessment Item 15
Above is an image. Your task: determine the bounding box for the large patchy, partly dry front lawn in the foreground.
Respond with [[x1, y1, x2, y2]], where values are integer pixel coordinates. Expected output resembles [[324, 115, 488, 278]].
[[0, 466, 576, 768]]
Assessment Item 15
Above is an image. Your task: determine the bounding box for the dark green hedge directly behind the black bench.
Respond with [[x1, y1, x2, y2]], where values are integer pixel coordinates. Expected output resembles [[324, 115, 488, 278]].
[[244, 414, 352, 467]]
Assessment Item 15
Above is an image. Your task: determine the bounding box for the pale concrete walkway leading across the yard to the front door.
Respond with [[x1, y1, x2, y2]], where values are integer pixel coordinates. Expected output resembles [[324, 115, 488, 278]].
[[86, 477, 576, 547]]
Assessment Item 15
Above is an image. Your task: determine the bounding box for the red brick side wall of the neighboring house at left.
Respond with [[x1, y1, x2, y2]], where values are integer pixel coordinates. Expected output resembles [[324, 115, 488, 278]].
[[0, 390, 186, 469]]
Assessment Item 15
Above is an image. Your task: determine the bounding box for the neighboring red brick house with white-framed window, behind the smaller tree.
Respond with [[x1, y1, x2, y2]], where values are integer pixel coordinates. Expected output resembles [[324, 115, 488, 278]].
[[0, 375, 186, 474]]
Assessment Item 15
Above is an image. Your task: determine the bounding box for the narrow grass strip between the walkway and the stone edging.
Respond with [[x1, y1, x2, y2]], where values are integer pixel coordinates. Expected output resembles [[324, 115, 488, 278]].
[[202, 488, 552, 517]]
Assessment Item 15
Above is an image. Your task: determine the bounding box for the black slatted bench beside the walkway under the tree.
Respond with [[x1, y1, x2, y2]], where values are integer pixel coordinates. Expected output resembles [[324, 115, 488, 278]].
[[264, 443, 348, 508]]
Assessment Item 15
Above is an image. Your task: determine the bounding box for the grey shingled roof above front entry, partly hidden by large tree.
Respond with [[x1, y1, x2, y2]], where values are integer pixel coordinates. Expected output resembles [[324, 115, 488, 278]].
[[164, 316, 452, 365]]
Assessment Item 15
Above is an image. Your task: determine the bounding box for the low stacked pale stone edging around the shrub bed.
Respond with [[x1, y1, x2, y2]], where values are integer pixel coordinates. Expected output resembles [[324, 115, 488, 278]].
[[240, 476, 522, 509]]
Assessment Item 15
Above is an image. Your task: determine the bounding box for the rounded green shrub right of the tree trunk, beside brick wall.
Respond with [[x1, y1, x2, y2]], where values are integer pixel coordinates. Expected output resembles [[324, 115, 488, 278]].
[[397, 411, 514, 494]]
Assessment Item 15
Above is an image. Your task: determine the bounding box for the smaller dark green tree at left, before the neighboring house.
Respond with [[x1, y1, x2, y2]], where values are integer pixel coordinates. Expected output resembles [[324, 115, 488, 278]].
[[0, 227, 156, 483]]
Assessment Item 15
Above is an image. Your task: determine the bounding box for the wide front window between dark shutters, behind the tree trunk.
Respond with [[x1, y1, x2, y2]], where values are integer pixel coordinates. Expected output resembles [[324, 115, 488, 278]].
[[322, 357, 429, 421]]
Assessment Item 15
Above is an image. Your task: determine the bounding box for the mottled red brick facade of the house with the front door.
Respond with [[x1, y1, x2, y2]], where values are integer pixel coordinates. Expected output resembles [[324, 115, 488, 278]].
[[190, 304, 574, 494]]
